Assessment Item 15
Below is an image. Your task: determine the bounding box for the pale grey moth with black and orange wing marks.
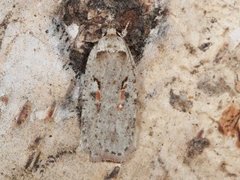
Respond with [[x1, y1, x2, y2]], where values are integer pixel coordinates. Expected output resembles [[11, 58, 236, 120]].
[[81, 28, 137, 163]]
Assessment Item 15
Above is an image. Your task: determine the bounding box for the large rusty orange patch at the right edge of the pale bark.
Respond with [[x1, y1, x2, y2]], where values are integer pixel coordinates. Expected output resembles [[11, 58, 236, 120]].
[[218, 104, 240, 147]]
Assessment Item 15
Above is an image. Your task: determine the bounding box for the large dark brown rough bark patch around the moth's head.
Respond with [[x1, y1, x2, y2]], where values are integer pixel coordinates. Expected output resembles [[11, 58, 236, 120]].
[[61, 0, 169, 76]]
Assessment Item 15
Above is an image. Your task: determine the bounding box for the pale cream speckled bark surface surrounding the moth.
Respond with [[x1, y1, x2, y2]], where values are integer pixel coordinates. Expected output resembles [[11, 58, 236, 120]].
[[0, 0, 240, 180]]
